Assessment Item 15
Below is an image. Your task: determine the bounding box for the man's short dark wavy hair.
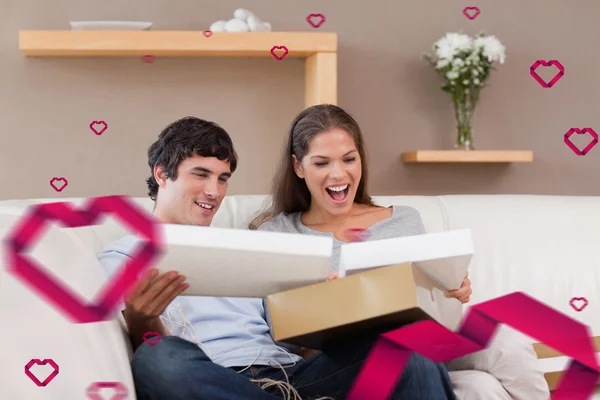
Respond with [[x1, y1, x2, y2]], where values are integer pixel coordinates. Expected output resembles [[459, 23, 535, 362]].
[[146, 117, 238, 201]]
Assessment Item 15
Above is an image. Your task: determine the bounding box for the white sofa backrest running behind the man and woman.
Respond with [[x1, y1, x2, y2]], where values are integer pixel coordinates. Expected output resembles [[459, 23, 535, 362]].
[[0, 195, 600, 335]]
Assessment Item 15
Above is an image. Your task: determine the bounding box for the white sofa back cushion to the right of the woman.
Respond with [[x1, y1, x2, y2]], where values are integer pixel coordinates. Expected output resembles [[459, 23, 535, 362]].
[[440, 195, 600, 335]]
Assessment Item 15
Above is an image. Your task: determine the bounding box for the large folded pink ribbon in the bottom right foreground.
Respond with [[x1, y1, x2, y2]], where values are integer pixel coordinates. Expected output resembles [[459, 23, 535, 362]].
[[347, 292, 600, 400]]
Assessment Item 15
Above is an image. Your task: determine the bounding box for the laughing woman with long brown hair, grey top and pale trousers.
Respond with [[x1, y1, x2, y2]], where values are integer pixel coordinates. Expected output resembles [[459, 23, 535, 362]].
[[250, 105, 549, 400]]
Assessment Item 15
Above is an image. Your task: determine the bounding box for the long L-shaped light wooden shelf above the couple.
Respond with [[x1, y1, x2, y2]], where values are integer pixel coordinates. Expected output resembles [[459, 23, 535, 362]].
[[19, 30, 337, 107]]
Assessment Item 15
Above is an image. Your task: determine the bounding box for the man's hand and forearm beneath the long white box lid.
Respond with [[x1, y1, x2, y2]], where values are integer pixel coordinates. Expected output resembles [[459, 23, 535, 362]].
[[123, 269, 189, 348]]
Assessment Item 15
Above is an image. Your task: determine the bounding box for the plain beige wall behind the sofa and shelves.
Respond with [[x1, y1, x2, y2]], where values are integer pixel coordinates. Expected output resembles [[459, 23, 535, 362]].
[[0, 0, 600, 199]]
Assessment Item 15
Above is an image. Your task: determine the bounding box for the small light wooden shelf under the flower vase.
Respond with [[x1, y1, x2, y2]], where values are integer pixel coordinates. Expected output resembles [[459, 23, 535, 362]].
[[402, 150, 533, 163]]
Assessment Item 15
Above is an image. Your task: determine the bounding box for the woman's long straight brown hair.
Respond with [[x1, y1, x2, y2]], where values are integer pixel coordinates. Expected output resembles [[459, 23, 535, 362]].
[[250, 104, 373, 229]]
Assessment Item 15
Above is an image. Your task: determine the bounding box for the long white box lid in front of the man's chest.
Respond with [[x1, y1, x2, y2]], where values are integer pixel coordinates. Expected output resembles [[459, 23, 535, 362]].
[[154, 224, 333, 298]]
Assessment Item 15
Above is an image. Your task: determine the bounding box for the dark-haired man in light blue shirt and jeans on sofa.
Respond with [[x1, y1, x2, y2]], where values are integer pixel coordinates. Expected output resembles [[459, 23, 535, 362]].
[[98, 117, 454, 400]]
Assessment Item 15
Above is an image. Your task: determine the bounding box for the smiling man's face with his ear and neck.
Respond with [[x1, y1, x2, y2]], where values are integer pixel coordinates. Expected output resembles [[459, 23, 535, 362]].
[[154, 154, 231, 226]]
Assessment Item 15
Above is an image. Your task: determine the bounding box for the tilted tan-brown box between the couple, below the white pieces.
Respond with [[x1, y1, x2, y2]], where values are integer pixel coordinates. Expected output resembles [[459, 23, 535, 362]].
[[267, 263, 437, 350]]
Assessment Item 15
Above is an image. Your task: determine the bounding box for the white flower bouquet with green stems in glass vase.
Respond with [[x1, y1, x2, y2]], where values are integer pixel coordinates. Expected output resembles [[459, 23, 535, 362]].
[[423, 33, 506, 150]]
